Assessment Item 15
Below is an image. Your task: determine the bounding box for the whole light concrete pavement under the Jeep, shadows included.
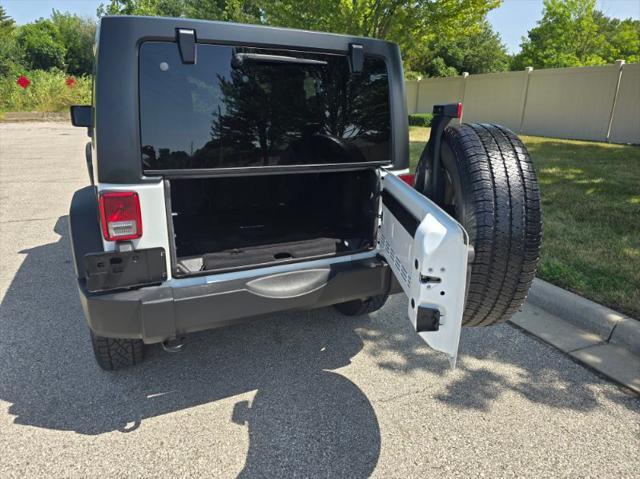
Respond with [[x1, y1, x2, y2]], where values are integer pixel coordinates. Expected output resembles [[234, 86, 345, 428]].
[[0, 123, 640, 478]]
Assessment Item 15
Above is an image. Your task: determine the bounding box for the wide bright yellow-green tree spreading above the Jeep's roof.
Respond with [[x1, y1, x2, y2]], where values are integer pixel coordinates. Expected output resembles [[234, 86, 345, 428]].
[[98, 0, 501, 72]]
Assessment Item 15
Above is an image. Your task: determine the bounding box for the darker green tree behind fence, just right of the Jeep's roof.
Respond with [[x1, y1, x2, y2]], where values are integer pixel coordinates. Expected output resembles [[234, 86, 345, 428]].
[[417, 20, 509, 77]]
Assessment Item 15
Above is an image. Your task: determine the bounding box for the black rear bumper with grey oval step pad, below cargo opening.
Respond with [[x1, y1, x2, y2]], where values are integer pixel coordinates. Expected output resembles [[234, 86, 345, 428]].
[[78, 258, 392, 343]]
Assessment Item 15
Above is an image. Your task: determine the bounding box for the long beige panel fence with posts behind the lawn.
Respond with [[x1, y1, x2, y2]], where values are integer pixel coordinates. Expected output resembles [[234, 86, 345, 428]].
[[406, 61, 640, 143]]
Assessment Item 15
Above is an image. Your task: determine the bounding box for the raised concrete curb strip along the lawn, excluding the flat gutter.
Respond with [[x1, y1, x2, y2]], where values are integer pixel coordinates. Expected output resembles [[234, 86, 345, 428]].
[[527, 278, 640, 355]]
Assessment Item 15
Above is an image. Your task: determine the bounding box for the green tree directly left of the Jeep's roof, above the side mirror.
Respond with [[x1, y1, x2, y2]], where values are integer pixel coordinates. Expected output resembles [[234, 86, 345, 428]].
[[51, 10, 96, 75]]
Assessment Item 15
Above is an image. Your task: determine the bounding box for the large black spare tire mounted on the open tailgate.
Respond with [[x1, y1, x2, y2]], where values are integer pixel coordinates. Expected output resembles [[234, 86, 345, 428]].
[[418, 124, 542, 326]]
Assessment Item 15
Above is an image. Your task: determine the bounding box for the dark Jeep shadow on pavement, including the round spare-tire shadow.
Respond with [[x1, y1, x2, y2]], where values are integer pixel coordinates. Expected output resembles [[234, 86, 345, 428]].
[[0, 217, 380, 477]]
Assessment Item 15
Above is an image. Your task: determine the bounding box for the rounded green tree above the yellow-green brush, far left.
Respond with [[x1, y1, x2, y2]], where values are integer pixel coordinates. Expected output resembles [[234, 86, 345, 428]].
[[17, 18, 67, 70]]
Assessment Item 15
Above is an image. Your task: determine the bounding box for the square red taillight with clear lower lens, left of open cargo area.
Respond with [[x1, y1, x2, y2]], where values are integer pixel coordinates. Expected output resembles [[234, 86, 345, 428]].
[[99, 191, 142, 241]]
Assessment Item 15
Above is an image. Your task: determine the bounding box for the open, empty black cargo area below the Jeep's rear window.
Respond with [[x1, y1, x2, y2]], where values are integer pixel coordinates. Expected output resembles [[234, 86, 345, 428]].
[[170, 169, 378, 275]]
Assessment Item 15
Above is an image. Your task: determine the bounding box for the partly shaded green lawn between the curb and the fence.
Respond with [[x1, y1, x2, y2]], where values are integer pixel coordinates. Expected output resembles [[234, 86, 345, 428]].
[[410, 127, 640, 318]]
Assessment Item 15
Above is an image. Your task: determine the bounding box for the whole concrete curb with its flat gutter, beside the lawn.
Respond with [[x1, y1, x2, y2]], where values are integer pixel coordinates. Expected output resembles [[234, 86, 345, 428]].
[[510, 279, 640, 394]]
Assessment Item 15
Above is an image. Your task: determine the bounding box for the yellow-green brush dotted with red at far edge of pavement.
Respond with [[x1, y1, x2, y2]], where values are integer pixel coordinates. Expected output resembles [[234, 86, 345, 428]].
[[0, 70, 91, 111]]
